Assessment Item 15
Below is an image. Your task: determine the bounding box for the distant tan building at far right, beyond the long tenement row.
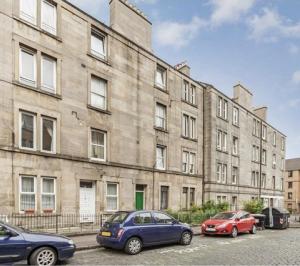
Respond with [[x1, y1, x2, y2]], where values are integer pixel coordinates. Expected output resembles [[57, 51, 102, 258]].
[[284, 158, 300, 213]]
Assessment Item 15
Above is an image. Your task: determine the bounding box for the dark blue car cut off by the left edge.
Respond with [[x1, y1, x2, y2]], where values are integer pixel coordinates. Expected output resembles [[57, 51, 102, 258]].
[[0, 222, 75, 266]]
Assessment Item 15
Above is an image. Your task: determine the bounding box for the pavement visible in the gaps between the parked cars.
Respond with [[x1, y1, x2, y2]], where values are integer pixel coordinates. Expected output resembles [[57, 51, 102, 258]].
[[70, 226, 200, 251]]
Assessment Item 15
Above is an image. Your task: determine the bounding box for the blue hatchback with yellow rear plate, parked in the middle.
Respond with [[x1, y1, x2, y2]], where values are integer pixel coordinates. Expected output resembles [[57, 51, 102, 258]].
[[97, 211, 193, 255]]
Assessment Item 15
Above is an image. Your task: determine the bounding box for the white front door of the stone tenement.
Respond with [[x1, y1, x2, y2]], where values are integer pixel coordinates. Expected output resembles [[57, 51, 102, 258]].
[[80, 181, 96, 223]]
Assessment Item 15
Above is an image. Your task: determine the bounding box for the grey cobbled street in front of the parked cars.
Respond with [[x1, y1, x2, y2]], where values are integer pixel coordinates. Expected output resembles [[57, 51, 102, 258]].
[[66, 229, 300, 265]]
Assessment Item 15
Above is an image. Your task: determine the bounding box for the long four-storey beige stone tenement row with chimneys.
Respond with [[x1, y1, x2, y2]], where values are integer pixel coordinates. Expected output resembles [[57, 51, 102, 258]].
[[0, 0, 285, 214]]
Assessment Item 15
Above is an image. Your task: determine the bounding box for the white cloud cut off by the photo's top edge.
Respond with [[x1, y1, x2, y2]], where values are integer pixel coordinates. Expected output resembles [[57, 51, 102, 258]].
[[209, 0, 255, 26]]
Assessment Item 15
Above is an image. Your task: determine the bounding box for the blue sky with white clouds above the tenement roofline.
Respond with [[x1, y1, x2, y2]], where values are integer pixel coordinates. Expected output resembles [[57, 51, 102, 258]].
[[70, 0, 300, 158]]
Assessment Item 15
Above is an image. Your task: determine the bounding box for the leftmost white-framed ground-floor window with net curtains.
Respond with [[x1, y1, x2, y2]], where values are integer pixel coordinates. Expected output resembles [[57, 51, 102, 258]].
[[20, 176, 36, 212]]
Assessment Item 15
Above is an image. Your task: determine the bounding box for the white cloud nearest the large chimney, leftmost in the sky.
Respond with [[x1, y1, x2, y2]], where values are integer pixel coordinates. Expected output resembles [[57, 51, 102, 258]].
[[154, 17, 207, 48]]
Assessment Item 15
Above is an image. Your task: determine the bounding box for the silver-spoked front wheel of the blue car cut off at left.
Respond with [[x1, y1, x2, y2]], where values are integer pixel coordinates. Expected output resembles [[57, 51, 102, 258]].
[[28, 247, 57, 266]]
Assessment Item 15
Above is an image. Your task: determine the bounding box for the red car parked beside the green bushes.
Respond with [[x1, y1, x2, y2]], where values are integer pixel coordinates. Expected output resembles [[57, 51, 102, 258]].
[[201, 211, 256, 237]]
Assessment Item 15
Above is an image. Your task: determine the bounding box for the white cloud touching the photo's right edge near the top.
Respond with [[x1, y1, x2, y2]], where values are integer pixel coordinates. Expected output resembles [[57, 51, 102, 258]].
[[248, 8, 300, 42]]
